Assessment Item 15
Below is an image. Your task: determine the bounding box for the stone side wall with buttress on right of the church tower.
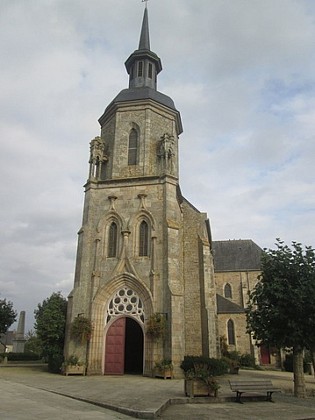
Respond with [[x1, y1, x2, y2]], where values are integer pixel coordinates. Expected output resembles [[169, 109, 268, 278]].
[[182, 200, 216, 356]]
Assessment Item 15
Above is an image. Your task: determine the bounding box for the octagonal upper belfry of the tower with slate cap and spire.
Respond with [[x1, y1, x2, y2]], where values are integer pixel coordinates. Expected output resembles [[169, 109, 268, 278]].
[[89, 8, 183, 182]]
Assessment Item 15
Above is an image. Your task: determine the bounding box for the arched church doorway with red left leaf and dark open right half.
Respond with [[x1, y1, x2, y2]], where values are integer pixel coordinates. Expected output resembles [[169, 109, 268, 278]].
[[104, 317, 143, 375]]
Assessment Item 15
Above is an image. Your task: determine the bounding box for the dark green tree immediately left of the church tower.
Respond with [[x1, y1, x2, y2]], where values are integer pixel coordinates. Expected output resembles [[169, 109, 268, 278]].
[[34, 292, 67, 373]]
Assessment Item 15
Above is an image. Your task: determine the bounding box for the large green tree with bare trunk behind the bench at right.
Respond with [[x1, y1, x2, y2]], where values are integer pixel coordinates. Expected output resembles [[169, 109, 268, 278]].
[[247, 239, 315, 398]]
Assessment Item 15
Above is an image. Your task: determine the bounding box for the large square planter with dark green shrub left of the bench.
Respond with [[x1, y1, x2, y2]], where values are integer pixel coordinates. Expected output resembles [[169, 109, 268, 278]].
[[180, 356, 227, 397]]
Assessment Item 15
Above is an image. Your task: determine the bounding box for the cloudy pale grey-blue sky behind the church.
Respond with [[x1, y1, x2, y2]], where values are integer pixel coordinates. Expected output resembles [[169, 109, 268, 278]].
[[0, 0, 315, 331]]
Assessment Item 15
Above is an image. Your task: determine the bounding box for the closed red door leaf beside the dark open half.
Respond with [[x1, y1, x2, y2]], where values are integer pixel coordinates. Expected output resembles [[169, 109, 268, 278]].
[[105, 318, 126, 375]]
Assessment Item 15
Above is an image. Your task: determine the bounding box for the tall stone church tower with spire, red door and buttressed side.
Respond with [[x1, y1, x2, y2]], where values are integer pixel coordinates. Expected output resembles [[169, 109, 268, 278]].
[[65, 8, 218, 376]]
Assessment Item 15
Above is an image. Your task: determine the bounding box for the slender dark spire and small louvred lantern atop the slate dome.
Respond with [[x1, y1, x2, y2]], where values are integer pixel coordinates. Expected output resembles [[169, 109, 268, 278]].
[[125, 7, 162, 90]]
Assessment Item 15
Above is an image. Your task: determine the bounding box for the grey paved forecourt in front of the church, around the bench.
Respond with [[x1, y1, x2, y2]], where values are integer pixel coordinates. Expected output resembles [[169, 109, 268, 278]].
[[0, 365, 315, 420]]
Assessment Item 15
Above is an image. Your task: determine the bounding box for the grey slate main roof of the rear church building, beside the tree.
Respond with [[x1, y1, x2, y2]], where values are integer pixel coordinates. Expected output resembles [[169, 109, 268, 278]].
[[212, 239, 263, 272]]
